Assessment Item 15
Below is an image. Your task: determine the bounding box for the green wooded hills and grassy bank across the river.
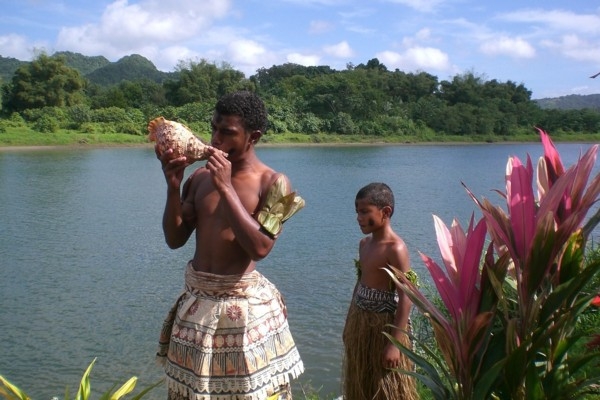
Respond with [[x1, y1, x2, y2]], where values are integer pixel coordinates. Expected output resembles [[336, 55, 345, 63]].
[[0, 52, 600, 149]]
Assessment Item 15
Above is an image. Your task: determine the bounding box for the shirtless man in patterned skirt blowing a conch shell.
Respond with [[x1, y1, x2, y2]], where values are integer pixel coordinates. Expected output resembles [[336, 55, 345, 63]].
[[149, 92, 304, 400]]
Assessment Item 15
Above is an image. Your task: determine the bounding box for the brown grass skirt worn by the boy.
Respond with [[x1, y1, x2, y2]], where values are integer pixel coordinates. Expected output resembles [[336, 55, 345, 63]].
[[342, 300, 418, 400]]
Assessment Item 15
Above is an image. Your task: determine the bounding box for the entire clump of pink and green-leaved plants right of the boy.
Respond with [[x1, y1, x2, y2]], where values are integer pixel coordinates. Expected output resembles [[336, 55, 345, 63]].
[[388, 130, 600, 399]]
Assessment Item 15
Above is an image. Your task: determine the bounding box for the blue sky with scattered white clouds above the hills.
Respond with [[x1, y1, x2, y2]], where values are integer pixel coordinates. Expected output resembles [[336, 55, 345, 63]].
[[0, 0, 600, 99]]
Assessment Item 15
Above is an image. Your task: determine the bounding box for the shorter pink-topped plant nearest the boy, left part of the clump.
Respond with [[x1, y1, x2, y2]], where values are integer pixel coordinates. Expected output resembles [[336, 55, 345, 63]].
[[388, 216, 508, 400]]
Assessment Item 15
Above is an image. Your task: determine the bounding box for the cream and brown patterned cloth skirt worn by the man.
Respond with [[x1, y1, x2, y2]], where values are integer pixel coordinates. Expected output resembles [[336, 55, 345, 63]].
[[157, 262, 304, 400]]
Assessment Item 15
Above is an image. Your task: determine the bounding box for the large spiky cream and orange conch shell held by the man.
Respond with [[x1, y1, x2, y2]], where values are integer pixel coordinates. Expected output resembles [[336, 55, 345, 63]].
[[148, 117, 225, 162]]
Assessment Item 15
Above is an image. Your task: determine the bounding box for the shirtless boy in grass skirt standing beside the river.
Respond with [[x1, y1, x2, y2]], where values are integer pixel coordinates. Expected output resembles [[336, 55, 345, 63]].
[[343, 183, 417, 400]]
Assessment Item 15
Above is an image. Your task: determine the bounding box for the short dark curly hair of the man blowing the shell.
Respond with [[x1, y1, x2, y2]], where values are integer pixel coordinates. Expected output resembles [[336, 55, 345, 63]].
[[215, 90, 268, 133]]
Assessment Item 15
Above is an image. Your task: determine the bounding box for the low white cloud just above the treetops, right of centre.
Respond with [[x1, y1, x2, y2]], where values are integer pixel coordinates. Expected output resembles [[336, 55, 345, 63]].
[[376, 47, 451, 71]]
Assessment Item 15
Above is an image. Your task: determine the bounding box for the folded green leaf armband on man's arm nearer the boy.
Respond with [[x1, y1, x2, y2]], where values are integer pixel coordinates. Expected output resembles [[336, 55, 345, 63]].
[[256, 175, 304, 237]]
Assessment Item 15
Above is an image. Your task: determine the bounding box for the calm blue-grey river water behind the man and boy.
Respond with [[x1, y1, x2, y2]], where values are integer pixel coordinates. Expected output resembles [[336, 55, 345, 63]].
[[0, 144, 598, 400]]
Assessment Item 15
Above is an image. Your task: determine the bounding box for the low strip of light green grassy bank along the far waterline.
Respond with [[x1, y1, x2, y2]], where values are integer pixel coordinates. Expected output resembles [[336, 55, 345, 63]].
[[0, 127, 600, 148]]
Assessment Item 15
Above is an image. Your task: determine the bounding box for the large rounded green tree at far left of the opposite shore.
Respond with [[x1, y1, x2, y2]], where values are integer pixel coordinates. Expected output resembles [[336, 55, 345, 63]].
[[2, 54, 86, 112]]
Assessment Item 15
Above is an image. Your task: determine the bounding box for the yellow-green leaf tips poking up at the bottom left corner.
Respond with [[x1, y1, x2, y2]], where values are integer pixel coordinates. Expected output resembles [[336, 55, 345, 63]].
[[0, 358, 163, 400]]
